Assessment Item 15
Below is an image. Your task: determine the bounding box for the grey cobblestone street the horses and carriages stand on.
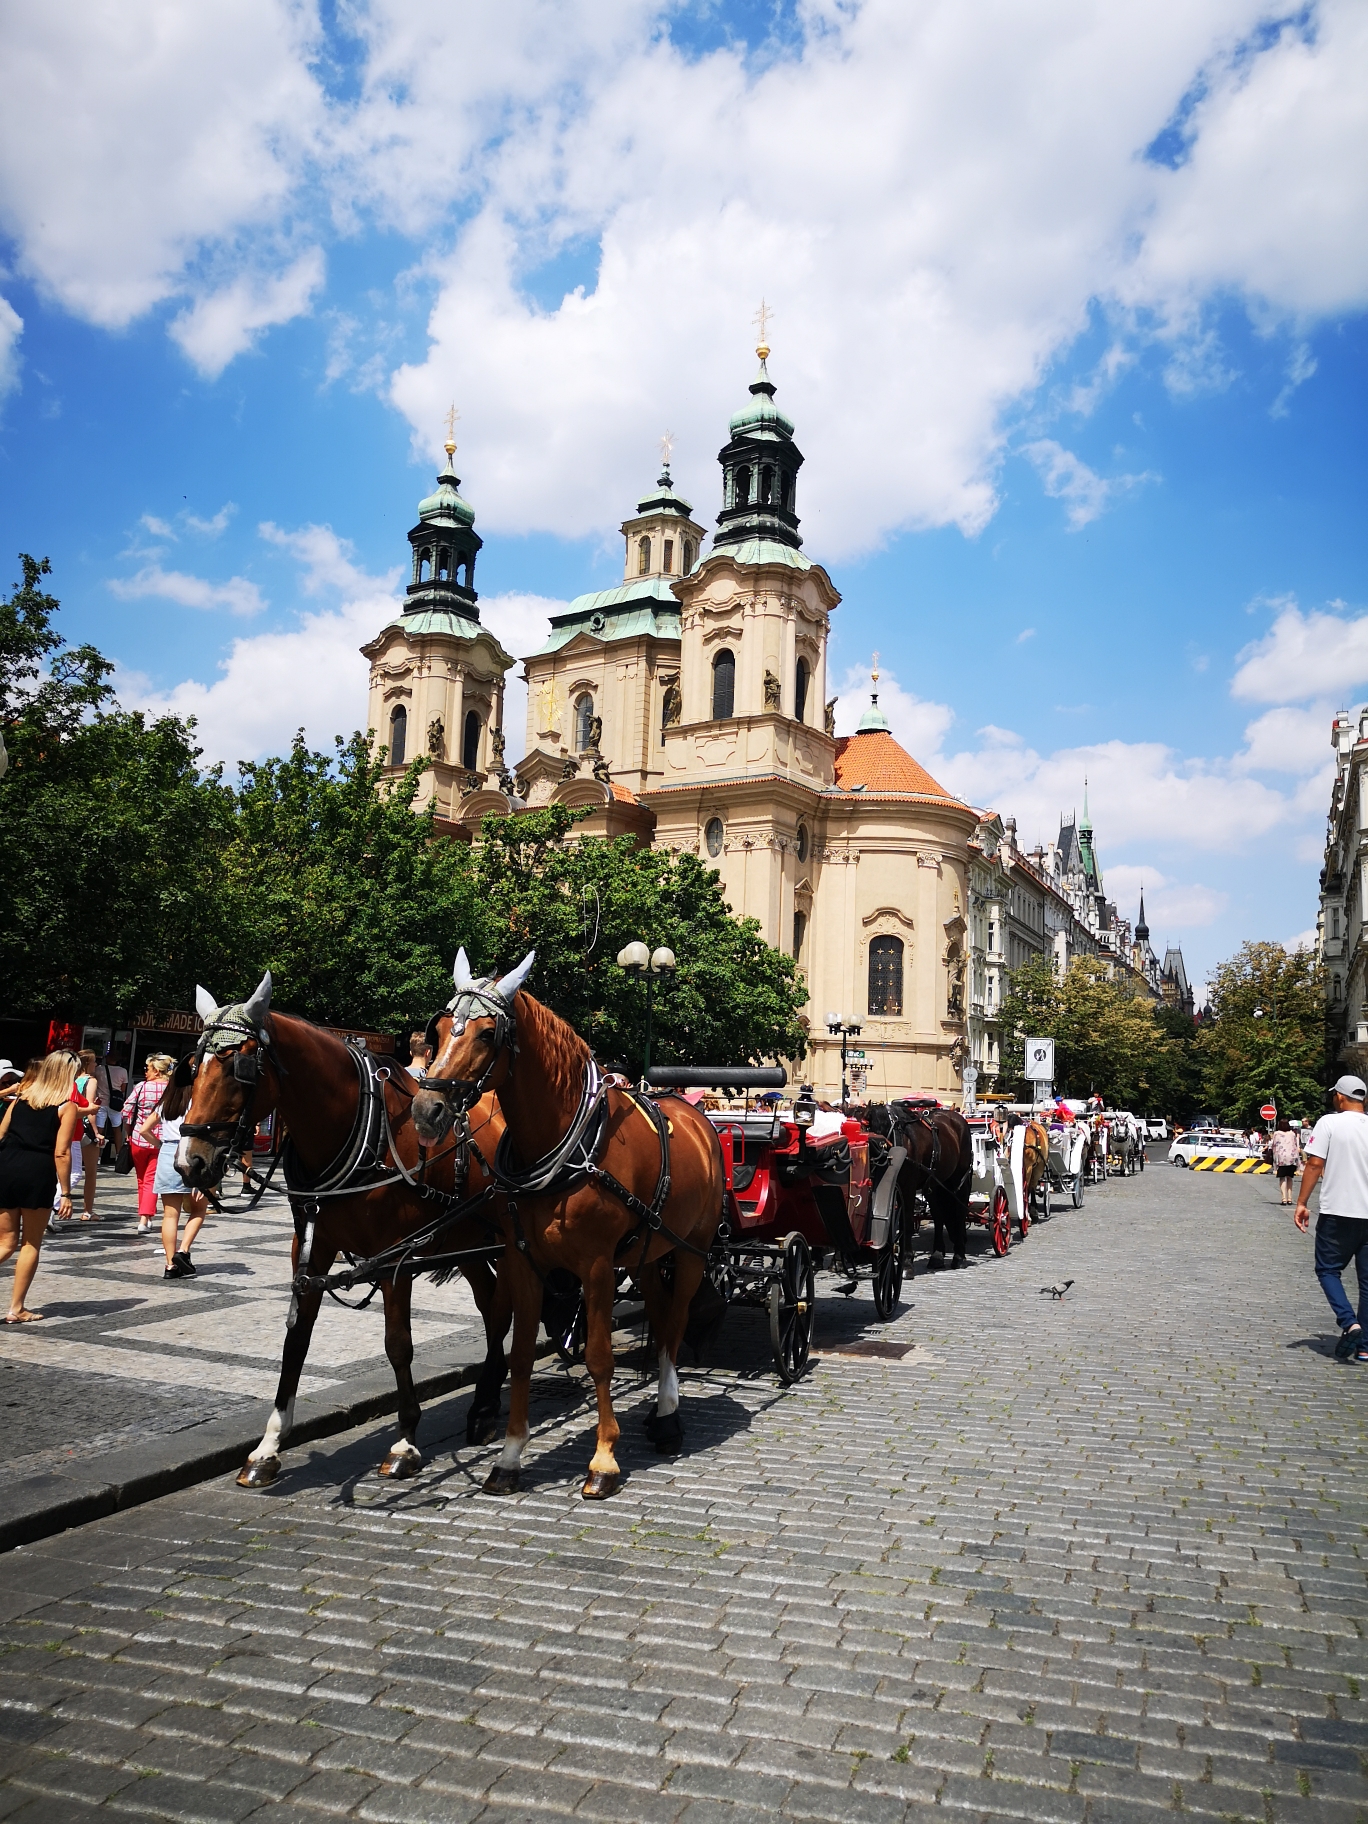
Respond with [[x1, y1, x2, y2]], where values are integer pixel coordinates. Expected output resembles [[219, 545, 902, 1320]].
[[0, 1166, 1368, 1824]]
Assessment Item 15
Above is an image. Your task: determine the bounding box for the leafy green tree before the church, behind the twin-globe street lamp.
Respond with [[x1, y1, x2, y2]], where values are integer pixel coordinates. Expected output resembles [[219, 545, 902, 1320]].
[[456, 804, 808, 1069]]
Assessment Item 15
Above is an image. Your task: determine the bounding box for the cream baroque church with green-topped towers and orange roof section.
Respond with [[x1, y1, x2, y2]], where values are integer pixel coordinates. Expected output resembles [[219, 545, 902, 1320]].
[[363, 343, 1021, 1102]]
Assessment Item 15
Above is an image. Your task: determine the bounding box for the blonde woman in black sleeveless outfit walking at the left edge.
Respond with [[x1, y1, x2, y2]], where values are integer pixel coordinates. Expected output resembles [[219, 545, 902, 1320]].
[[0, 1051, 82, 1324]]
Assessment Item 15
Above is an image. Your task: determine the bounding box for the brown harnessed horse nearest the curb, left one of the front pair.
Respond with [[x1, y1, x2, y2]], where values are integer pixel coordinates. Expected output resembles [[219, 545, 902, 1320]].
[[175, 974, 511, 1488]]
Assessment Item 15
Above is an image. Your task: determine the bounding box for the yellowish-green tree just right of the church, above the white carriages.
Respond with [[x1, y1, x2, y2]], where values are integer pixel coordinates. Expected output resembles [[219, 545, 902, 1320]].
[[1000, 956, 1176, 1111]]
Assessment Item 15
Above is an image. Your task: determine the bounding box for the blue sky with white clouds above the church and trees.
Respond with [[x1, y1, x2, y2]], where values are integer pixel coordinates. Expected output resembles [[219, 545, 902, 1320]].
[[0, 0, 1368, 999]]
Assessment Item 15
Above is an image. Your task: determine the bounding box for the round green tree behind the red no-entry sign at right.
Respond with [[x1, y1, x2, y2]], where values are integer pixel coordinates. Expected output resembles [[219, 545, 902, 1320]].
[[1198, 943, 1324, 1125]]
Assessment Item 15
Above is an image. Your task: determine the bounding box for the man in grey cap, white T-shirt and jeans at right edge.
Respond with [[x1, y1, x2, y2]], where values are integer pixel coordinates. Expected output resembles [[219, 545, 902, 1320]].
[[1293, 1076, 1368, 1363]]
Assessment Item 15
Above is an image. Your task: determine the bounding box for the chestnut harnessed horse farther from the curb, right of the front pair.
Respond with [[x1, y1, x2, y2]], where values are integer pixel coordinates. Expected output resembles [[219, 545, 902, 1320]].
[[414, 950, 724, 1501]]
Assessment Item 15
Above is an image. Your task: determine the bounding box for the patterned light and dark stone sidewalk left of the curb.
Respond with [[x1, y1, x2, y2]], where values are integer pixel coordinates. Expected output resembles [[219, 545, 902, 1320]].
[[0, 1173, 483, 1476]]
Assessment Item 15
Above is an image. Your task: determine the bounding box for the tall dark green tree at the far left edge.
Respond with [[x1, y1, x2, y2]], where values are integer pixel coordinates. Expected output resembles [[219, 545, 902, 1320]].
[[0, 554, 237, 1018]]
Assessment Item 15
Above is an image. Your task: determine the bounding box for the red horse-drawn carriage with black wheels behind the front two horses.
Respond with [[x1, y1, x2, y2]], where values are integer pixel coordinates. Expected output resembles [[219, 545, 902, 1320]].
[[648, 1065, 907, 1383]]
